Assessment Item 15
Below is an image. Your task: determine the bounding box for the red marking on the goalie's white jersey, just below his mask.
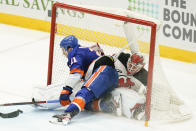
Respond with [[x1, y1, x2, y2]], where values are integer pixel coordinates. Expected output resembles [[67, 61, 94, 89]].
[[118, 76, 135, 87]]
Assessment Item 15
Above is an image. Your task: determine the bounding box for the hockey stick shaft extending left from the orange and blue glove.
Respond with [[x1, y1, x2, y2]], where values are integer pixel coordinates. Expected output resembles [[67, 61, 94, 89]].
[[0, 100, 59, 106]]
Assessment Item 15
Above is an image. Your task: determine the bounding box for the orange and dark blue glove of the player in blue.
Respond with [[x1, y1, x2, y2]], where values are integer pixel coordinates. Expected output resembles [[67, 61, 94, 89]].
[[59, 86, 72, 106]]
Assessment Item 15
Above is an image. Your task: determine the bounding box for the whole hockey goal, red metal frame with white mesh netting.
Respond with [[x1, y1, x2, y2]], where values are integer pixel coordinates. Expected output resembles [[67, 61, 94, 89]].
[[47, 3, 191, 124]]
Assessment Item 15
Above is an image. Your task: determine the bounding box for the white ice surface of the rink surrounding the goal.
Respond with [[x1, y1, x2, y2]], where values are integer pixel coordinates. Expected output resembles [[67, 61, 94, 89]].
[[0, 24, 196, 131]]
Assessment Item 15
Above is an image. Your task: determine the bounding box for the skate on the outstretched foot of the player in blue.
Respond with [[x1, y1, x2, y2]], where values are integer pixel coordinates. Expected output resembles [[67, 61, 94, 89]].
[[49, 112, 72, 126]]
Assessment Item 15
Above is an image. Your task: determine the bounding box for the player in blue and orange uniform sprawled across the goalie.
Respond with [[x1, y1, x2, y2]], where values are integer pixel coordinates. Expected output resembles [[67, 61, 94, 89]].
[[51, 35, 118, 125]]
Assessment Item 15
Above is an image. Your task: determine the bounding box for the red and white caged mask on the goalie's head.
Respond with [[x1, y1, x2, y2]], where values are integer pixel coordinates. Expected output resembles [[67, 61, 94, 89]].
[[127, 54, 145, 75]]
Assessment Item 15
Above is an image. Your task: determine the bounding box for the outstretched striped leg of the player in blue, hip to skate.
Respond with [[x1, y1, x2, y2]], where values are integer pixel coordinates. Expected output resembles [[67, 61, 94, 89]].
[[50, 66, 118, 124]]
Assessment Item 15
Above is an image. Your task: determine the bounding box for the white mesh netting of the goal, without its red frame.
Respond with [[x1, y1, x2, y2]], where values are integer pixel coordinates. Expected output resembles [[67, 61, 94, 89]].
[[49, 2, 191, 121]]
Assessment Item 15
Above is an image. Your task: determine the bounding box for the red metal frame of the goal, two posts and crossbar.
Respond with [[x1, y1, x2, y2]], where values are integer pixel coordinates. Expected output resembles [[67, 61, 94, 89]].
[[47, 2, 157, 124]]
